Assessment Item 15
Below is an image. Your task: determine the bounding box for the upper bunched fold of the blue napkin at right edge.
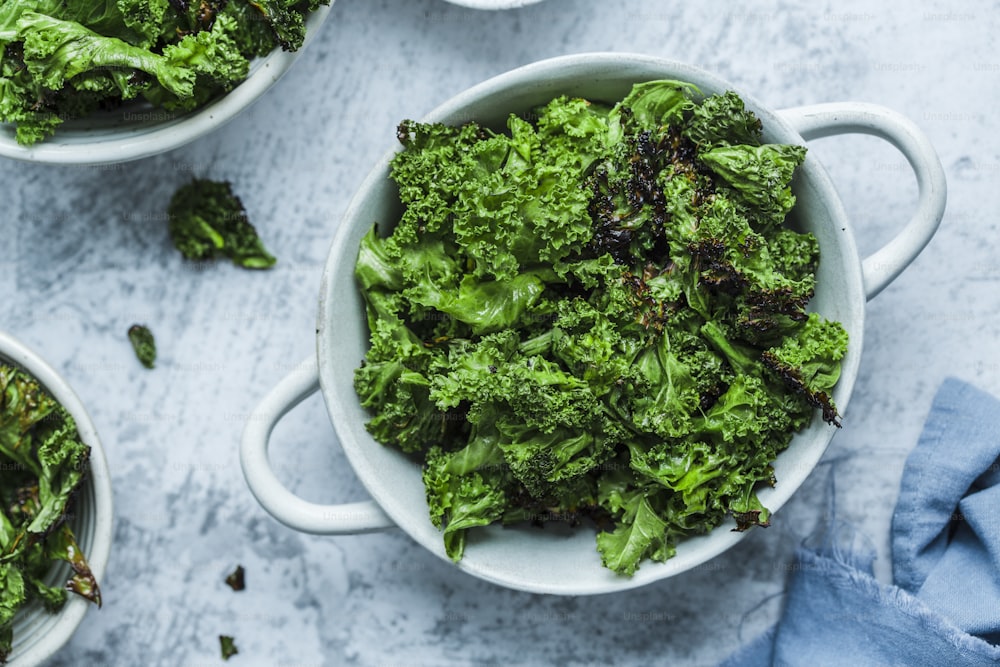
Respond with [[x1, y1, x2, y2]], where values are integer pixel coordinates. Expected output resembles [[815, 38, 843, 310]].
[[892, 378, 1000, 636]]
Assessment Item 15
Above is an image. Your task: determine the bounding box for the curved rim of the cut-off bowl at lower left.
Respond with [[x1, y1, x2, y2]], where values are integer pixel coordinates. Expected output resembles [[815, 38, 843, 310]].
[[0, 331, 114, 665]]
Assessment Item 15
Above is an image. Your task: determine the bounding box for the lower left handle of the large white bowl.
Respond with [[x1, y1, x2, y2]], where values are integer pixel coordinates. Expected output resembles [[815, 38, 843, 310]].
[[240, 357, 395, 535]]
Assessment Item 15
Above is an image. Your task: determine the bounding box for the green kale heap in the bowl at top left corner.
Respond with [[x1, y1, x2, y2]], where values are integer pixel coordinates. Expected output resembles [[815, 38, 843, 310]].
[[0, 0, 329, 145]]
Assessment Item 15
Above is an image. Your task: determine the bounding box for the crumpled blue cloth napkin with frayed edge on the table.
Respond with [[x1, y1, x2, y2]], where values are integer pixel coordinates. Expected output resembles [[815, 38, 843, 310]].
[[723, 378, 1000, 667]]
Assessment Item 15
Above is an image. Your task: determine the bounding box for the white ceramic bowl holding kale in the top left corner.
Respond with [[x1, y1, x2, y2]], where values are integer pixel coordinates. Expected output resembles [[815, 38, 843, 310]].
[[0, 5, 333, 165]]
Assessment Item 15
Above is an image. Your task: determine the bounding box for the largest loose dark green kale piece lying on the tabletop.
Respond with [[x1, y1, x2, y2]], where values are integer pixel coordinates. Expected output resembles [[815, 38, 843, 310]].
[[167, 178, 276, 269]]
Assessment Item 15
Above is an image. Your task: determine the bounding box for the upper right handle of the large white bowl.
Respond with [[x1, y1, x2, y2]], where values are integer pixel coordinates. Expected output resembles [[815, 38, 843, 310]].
[[778, 102, 947, 300]]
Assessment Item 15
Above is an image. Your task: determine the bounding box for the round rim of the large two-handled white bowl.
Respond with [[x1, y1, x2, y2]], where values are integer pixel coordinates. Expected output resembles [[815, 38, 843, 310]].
[[316, 52, 866, 595]]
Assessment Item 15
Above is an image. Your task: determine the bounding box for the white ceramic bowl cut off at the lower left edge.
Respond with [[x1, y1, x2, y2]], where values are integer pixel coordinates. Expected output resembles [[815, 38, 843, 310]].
[[0, 333, 113, 667]]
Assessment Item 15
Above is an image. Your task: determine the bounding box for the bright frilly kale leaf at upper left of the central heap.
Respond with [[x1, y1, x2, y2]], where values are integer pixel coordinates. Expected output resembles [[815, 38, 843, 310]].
[[392, 102, 606, 281]]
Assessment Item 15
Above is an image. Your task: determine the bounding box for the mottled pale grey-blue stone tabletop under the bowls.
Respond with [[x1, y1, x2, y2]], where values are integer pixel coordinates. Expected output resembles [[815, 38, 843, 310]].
[[0, 0, 1000, 667]]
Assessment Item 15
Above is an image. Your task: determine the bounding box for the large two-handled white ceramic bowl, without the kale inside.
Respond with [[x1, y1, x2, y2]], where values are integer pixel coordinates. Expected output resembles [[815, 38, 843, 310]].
[[241, 53, 945, 595]]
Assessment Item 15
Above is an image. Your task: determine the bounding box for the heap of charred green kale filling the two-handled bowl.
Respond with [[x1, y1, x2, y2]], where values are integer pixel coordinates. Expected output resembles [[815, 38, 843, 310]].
[[355, 81, 847, 575]]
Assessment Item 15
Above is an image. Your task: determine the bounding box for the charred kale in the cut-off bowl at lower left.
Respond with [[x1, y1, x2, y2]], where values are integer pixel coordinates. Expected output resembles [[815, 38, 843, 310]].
[[0, 364, 101, 662]]
